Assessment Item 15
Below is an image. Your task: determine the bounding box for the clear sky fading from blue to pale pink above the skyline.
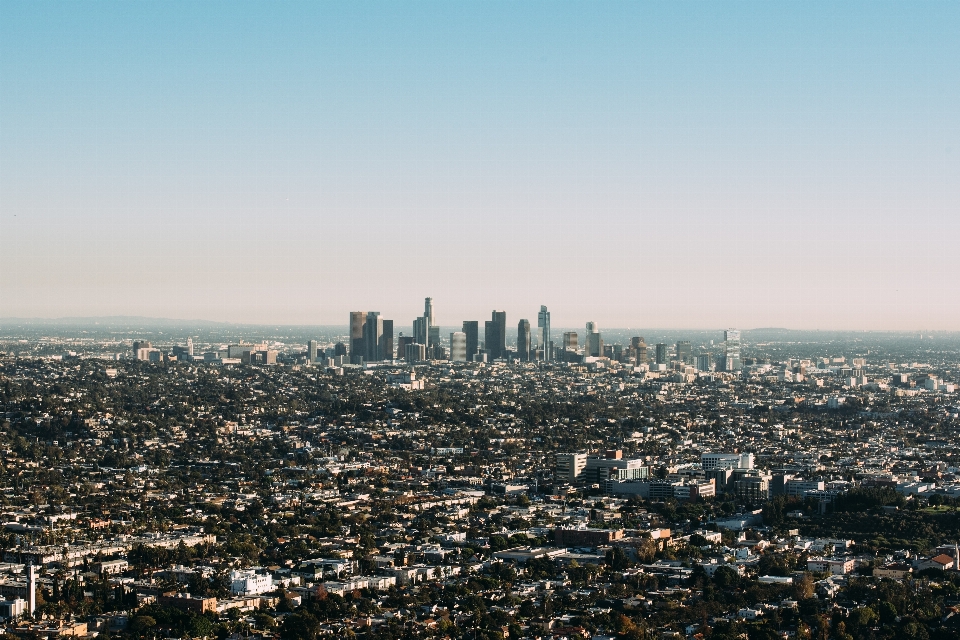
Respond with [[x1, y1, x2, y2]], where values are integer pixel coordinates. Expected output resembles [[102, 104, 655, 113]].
[[0, 0, 960, 330]]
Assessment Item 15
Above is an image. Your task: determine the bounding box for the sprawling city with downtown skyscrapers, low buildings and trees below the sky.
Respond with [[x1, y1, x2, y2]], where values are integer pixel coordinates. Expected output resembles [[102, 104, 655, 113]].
[[0, 298, 960, 640]]
